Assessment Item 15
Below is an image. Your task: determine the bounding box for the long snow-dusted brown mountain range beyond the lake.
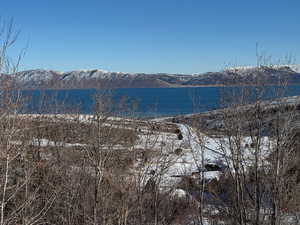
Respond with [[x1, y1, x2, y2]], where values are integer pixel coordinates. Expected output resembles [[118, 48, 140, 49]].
[[6, 65, 300, 88]]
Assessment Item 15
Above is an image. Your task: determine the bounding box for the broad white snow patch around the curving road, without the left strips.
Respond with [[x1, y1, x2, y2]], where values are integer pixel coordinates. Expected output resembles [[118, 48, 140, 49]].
[[136, 121, 272, 186]]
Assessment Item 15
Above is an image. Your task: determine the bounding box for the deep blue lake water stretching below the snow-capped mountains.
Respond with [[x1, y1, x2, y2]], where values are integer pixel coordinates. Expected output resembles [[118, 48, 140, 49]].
[[23, 86, 300, 117]]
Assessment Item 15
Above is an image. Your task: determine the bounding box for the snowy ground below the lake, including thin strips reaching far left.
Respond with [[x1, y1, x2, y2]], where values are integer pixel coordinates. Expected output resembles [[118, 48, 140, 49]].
[[14, 115, 270, 186]]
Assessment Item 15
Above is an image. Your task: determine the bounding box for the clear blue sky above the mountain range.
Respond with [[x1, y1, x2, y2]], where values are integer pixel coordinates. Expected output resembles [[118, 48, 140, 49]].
[[0, 0, 300, 73]]
